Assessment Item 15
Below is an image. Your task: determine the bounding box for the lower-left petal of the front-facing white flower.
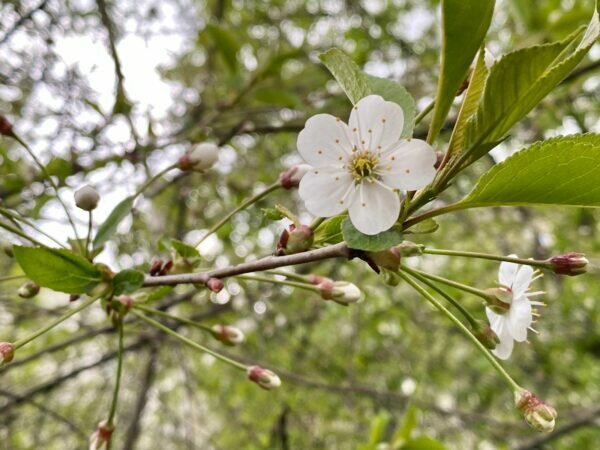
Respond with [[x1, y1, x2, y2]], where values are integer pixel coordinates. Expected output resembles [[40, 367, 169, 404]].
[[298, 167, 355, 217]]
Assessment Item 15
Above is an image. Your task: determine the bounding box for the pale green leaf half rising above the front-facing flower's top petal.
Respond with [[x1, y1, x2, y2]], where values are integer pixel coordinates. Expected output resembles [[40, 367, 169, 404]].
[[319, 48, 371, 104]]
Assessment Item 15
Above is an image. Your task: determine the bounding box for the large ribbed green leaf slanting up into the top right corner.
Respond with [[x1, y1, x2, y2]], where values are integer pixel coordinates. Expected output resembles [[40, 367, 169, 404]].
[[463, 4, 600, 167]]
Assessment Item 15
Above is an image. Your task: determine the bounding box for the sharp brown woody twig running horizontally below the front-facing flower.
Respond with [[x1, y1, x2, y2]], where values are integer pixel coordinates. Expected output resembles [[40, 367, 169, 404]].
[[144, 242, 350, 287]]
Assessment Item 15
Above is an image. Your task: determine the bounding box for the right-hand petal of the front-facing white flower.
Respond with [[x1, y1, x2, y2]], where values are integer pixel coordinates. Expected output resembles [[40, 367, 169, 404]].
[[379, 139, 437, 191]]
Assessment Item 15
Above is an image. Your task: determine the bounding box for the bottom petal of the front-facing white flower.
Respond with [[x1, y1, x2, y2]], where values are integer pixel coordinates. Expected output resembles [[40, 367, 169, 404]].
[[348, 180, 400, 235]]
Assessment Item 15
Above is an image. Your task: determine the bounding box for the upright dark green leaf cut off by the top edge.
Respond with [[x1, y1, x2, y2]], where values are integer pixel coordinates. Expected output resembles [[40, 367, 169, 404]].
[[427, 0, 495, 142]]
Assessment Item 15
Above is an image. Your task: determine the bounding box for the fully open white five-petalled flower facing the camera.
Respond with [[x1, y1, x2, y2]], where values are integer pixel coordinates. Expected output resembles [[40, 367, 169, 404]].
[[298, 95, 436, 235]]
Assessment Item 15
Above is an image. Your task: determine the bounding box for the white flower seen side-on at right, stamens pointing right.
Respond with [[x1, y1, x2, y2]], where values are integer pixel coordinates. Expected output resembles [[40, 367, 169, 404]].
[[485, 255, 543, 359]]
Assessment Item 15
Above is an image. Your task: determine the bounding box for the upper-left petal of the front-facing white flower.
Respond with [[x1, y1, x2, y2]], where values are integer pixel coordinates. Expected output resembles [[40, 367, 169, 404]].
[[297, 114, 352, 167]]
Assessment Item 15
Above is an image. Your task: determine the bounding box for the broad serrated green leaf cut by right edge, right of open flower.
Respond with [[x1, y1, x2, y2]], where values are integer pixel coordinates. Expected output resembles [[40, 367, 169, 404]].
[[456, 134, 600, 209]]
